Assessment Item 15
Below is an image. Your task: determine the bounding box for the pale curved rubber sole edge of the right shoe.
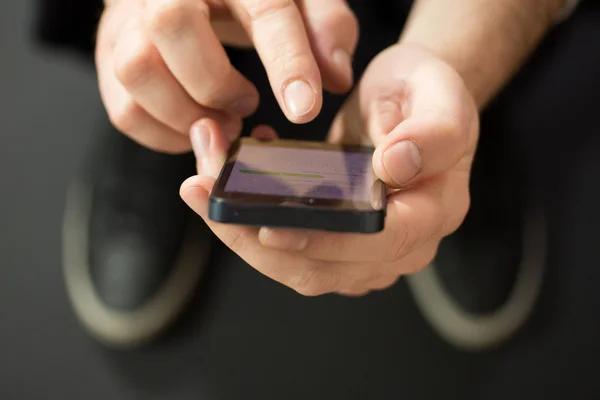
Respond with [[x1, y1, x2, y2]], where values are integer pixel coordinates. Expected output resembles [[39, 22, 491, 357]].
[[406, 205, 546, 351]]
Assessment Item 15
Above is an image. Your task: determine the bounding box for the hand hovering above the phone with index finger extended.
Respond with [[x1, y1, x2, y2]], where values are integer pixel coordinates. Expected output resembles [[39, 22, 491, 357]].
[[96, 0, 358, 153]]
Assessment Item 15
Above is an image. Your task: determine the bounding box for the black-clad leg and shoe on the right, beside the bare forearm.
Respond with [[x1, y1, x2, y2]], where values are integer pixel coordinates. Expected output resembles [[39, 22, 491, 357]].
[[409, 2, 600, 349]]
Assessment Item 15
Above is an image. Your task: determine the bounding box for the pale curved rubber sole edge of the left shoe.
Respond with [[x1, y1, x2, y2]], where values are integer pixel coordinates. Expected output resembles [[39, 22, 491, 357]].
[[62, 181, 210, 347]]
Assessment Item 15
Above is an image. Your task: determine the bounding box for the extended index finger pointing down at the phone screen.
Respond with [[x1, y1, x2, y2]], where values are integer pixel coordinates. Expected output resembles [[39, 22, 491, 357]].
[[227, 0, 323, 123]]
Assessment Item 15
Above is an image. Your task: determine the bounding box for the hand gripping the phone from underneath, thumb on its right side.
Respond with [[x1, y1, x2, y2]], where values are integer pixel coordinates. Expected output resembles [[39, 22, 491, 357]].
[[181, 45, 479, 295]]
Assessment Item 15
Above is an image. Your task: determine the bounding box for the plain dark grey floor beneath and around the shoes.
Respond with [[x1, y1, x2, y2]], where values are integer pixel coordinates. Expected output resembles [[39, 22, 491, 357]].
[[0, 0, 600, 400]]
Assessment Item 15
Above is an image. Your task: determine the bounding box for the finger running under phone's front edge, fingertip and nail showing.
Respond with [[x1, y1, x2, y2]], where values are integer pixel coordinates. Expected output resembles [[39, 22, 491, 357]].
[[259, 173, 469, 262]]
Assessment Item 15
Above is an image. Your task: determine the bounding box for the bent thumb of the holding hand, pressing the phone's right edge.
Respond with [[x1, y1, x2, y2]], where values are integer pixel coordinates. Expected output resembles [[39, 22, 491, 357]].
[[368, 55, 478, 188]]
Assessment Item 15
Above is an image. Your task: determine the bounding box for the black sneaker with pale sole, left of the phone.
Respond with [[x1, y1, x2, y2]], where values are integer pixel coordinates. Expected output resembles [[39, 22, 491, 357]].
[[63, 128, 211, 347]]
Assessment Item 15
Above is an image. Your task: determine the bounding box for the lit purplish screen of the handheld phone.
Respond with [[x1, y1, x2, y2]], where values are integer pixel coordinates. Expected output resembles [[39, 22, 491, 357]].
[[224, 143, 377, 203]]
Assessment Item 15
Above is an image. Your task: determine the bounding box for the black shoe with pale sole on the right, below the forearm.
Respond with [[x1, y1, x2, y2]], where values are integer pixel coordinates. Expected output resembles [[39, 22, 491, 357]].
[[407, 142, 546, 351]]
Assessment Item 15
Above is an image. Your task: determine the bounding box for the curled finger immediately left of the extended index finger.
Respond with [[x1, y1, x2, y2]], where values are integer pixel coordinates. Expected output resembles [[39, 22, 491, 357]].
[[145, 0, 258, 116]]
